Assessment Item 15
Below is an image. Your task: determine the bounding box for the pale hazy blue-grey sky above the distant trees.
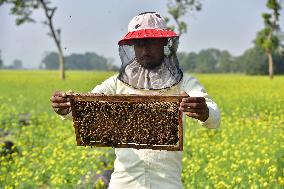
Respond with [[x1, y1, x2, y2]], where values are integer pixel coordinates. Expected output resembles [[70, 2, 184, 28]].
[[0, 0, 284, 68]]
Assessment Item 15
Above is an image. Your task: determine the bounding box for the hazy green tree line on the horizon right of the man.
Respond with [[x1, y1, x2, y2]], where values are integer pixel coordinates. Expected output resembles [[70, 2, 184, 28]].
[[178, 47, 284, 75]]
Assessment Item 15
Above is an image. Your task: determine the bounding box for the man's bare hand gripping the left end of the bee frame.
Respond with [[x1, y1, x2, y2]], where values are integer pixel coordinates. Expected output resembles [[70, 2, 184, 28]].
[[50, 91, 71, 115]]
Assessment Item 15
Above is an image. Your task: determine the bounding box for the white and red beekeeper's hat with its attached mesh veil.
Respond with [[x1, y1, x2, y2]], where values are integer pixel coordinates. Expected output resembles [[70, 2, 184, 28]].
[[118, 12, 183, 90]]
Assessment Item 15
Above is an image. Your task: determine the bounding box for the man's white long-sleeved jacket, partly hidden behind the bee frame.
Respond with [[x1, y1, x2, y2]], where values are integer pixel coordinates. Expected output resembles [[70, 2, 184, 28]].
[[89, 75, 220, 189]]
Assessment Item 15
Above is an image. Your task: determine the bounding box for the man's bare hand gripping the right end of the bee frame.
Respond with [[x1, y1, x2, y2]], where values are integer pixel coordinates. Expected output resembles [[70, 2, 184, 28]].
[[179, 91, 209, 122]]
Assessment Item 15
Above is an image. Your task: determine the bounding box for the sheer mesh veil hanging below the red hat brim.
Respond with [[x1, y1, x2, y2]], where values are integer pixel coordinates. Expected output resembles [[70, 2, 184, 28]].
[[118, 37, 183, 90]]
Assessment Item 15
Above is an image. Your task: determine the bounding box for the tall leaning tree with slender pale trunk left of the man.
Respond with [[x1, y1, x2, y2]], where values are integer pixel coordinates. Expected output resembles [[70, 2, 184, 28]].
[[0, 0, 65, 80]]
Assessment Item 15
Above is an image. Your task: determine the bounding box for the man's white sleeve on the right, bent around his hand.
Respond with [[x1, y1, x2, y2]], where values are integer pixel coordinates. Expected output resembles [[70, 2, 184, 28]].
[[182, 76, 220, 129]]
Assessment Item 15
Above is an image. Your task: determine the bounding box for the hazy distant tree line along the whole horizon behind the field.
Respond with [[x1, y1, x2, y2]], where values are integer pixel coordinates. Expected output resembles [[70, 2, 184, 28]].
[[0, 46, 284, 75]]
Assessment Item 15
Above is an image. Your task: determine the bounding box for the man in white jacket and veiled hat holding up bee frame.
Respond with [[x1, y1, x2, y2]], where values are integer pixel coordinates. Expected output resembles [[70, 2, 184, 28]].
[[51, 12, 220, 188]]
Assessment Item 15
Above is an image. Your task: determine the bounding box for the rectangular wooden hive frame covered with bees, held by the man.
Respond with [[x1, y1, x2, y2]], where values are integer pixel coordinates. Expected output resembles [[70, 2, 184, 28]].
[[70, 94, 182, 150]]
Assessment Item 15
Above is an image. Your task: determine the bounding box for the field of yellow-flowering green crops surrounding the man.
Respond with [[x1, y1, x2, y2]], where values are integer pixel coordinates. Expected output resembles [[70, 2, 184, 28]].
[[0, 71, 284, 189]]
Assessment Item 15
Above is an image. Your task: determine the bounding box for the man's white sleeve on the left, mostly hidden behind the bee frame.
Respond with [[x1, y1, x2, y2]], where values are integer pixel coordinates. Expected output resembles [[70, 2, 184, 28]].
[[60, 75, 117, 120]]
